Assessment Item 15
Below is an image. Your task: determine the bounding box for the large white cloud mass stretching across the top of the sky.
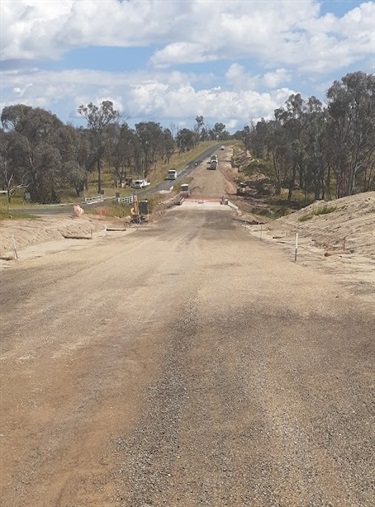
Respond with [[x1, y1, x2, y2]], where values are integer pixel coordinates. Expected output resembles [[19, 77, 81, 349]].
[[1, 0, 375, 73]]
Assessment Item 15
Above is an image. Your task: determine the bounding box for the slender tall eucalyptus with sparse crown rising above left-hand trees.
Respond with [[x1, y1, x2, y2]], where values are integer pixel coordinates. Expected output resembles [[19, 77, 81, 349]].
[[78, 100, 120, 193]]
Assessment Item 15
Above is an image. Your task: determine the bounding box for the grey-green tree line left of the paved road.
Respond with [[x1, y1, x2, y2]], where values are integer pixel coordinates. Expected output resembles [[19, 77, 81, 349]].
[[0, 101, 229, 203]]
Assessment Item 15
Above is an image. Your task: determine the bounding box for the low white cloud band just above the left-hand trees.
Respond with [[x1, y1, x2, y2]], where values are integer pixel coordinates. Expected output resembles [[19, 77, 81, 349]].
[[0, 67, 294, 126]]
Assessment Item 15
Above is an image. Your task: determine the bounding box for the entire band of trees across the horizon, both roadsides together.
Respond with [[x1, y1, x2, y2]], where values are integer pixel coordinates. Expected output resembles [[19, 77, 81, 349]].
[[0, 72, 375, 203]]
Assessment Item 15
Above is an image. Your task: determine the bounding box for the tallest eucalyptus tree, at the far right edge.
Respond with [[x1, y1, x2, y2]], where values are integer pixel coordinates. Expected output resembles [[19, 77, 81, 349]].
[[327, 72, 375, 197]]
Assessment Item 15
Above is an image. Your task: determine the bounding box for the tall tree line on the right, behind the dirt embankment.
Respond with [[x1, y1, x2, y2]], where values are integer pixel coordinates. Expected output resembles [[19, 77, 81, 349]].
[[234, 72, 375, 201]]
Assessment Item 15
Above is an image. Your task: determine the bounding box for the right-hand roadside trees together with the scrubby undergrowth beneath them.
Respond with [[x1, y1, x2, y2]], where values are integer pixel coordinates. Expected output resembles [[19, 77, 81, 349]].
[[232, 72, 375, 220]]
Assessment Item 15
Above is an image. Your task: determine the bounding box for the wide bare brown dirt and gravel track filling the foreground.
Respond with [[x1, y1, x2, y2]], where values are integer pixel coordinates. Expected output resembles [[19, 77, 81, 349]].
[[0, 149, 375, 507]]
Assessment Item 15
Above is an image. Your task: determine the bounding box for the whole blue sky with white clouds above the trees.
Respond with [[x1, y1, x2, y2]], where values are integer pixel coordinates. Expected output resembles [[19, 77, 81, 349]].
[[0, 0, 375, 132]]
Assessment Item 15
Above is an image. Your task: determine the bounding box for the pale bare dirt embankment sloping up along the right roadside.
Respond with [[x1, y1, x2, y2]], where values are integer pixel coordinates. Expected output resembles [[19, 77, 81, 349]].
[[221, 147, 375, 301]]
